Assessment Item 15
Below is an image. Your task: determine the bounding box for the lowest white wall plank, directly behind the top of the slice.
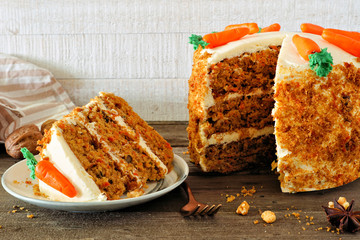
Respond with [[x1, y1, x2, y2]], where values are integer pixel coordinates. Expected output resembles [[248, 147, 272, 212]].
[[59, 79, 188, 121]]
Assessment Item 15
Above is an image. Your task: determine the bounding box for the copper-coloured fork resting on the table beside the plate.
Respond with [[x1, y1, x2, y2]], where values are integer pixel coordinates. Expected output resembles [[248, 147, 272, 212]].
[[180, 181, 222, 217]]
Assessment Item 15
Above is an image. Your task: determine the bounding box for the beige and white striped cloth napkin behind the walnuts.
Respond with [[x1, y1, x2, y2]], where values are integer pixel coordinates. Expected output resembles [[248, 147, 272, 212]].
[[0, 54, 75, 142]]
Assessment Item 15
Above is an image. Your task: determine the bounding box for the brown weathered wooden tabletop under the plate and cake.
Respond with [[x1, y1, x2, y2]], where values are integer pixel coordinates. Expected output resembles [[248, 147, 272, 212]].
[[0, 123, 360, 239]]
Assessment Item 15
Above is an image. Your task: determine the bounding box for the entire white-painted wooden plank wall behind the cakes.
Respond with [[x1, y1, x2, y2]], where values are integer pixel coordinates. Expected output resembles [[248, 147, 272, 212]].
[[0, 0, 360, 121]]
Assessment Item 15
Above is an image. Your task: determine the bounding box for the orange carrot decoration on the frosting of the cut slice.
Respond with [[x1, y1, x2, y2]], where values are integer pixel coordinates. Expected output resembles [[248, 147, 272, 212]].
[[35, 160, 77, 198]]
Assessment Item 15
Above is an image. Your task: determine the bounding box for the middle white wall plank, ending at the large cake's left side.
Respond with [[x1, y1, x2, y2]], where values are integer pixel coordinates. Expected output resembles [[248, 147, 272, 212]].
[[0, 33, 193, 79]]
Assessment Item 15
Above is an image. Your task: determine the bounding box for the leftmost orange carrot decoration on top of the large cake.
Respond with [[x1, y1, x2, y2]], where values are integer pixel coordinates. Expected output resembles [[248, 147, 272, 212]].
[[203, 28, 249, 48]]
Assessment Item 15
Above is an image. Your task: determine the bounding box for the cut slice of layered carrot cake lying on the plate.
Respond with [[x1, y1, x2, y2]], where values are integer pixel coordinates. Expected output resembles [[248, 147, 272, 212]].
[[35, 92, 173, 201]]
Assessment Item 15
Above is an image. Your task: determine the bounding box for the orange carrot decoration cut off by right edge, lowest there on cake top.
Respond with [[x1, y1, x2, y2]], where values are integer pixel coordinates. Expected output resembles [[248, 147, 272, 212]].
[[321, 30, 360, 57]]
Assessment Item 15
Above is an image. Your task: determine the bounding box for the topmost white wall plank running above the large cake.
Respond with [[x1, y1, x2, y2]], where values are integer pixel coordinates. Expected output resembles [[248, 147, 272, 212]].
[[0, 0, 360, 35]]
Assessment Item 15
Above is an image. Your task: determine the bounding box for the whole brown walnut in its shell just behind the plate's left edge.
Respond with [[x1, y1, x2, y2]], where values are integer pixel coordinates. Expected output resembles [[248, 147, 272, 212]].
[[5, 124, 43, 159]]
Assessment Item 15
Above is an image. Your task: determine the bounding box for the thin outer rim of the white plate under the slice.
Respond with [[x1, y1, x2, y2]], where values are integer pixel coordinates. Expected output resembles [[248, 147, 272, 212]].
[[1, 154, 189, 212]]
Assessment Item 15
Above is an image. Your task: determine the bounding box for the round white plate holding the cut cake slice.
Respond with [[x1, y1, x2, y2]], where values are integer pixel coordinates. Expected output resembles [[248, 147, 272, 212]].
[[1, 155, 189, 212]]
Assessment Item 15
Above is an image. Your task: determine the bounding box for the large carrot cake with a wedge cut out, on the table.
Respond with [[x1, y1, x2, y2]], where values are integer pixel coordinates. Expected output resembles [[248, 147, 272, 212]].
[[187, 23, 360, 192]]
